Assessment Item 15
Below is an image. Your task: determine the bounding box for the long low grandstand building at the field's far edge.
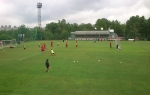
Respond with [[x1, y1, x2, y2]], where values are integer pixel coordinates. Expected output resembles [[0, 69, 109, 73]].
[[69, 29, 125, 40]]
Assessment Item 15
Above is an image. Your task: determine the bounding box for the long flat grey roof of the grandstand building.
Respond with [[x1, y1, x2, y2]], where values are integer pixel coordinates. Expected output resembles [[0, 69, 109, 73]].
[[71, 31, 109, 35]]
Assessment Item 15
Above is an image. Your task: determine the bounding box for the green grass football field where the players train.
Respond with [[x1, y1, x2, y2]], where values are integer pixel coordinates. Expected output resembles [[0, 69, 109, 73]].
[[0, 41, 150, 95]]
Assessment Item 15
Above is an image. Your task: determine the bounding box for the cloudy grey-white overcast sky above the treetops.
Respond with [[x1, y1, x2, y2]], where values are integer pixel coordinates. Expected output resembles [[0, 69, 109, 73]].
[[0, 0, 150, 27]]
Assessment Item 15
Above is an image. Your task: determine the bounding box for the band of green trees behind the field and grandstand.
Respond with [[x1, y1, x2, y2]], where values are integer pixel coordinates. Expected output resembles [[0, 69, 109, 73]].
[[0, 15, 150, 41]]
